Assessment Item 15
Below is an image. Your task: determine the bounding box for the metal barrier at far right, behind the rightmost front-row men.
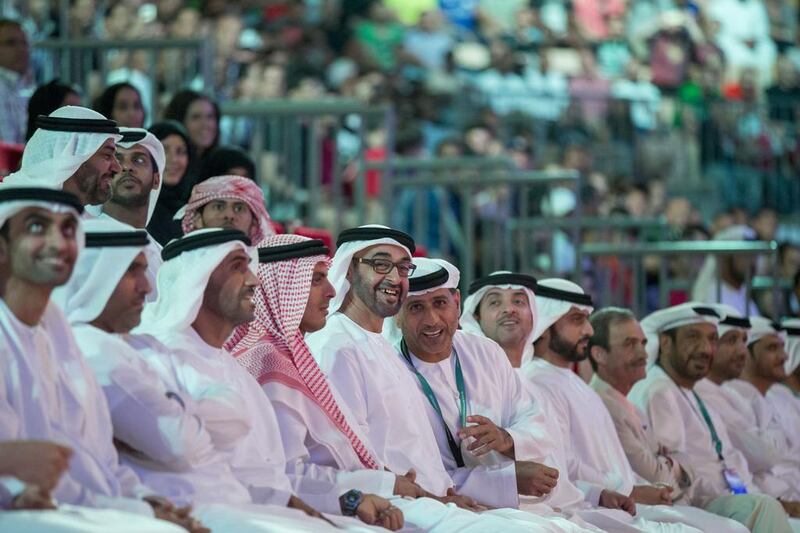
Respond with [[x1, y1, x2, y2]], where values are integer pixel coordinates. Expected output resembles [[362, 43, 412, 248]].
[[580, 241, 780, 316]]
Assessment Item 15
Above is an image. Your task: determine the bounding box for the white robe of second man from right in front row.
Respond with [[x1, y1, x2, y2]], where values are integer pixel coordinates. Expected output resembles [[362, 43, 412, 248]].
[[722, 379, 800, 501]]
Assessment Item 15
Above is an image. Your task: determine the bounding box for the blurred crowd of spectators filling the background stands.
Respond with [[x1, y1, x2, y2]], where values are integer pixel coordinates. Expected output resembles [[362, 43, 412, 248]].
[[0, 0, 800, 314]]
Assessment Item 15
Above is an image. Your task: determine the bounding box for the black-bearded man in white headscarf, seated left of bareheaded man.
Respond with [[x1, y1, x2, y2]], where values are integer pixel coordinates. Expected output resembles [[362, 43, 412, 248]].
[[520, 278, 735, 531]]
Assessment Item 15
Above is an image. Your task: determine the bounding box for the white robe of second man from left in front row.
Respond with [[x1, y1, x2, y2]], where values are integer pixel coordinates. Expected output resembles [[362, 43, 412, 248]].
[[87, 325, 372, 533]]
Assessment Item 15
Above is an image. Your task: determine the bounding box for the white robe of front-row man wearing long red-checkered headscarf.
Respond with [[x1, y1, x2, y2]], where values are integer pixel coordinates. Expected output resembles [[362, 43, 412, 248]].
[[262, 350, 580, 533]]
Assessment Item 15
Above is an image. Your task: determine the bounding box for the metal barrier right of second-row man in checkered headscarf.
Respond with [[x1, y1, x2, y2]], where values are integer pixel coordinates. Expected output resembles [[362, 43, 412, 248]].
[[220, 98, 393, 233]]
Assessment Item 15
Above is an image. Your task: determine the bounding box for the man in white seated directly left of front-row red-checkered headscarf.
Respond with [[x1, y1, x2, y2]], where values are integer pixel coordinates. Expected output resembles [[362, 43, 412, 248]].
[[129, 228, 358, 530]]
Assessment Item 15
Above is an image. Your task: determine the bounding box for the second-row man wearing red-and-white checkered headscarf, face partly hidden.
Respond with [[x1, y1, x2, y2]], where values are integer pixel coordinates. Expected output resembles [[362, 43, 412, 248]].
[[175, 176, 275, 243]]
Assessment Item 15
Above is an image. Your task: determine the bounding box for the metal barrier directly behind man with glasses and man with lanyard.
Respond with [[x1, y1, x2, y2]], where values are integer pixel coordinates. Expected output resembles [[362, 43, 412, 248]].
[[367, 157, 580, 288]]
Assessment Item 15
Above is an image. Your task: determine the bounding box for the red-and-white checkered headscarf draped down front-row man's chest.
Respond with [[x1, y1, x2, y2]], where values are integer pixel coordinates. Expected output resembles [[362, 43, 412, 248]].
[[225, 235, 378, 469]]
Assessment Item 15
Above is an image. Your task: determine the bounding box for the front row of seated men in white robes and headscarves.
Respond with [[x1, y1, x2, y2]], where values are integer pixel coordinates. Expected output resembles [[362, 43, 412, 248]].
[[0, 105, 800, 532]]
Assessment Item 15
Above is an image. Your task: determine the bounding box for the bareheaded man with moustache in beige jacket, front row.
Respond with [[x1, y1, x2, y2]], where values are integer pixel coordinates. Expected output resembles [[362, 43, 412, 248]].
[[589, 307, 692, 502]]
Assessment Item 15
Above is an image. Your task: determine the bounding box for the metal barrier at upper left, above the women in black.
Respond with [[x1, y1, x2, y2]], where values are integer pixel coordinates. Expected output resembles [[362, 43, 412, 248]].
[[33, 38, 213, 117]]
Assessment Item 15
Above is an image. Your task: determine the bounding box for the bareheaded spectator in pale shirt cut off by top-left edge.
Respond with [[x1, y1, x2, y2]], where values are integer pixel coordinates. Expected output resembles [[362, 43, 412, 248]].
[[0, 19, 31, 143]]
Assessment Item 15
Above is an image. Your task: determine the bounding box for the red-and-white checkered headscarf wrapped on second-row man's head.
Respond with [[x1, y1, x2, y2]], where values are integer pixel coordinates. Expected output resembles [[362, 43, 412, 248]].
[[181, 176, 275, 243]]
